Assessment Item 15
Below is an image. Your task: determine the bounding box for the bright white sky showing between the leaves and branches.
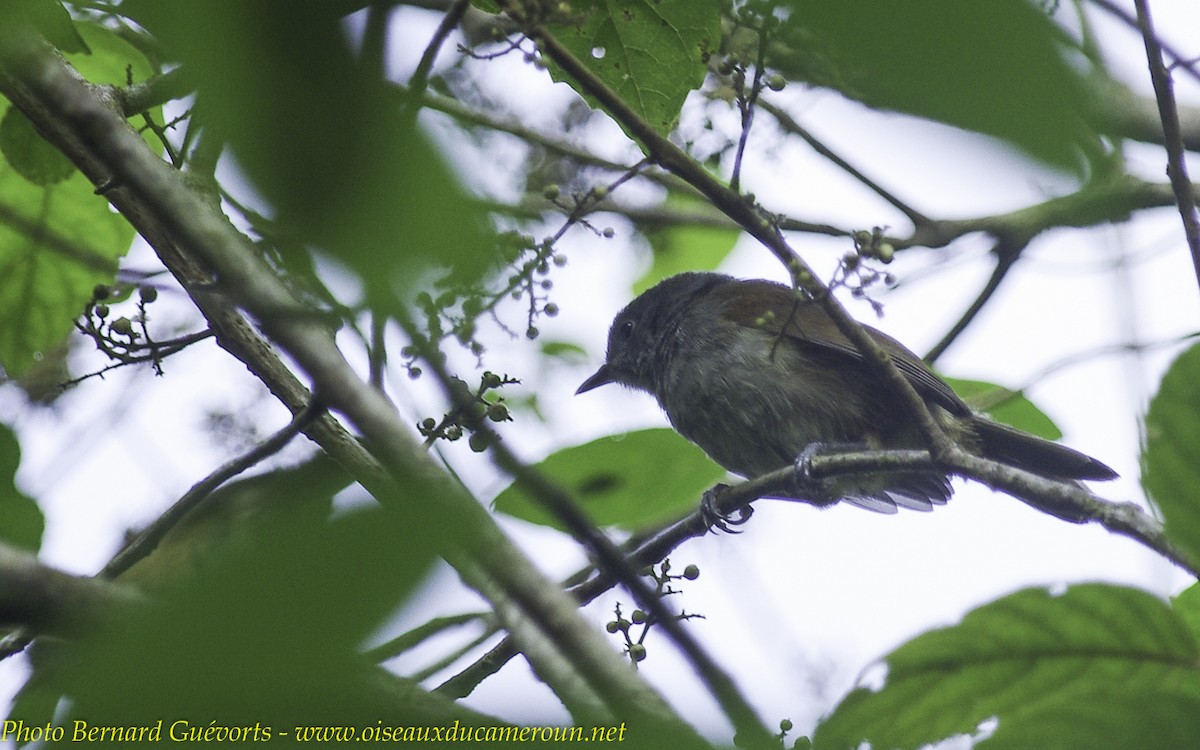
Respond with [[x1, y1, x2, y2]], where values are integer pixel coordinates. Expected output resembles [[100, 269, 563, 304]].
[[0, 0, 1200, 737]]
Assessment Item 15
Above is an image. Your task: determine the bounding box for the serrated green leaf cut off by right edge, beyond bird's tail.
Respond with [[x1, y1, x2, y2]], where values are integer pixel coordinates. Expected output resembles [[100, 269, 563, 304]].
[[1141, 344, 1200, 559]]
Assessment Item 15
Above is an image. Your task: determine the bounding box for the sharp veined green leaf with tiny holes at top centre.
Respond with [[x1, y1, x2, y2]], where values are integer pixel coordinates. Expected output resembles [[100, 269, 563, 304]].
[[550, 0, 721, 136]]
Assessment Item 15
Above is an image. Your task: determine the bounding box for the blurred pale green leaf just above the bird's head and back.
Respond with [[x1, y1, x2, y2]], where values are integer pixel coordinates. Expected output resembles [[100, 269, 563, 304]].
[[634, 193, 742, 296]]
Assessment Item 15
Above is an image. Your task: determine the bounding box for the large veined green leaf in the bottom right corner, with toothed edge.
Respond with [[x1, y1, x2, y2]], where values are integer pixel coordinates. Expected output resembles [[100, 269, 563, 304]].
[[814, 583, 1200, 750]]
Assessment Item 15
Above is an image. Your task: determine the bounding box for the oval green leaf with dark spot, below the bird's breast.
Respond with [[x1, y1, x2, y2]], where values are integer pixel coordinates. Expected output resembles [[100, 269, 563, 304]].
[[494, 430, 725, 532]]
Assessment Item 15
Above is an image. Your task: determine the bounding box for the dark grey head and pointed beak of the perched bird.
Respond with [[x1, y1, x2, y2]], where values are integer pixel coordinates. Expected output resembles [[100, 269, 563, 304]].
[[575, 272, 734, 394]]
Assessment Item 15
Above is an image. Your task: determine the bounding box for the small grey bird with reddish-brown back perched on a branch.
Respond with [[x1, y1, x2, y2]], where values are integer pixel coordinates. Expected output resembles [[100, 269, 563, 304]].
[[576, 272, 1117, 521]]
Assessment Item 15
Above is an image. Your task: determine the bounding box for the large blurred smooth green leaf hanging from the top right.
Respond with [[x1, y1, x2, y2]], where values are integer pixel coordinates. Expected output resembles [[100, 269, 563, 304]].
[[768, 0, 1099, 170]]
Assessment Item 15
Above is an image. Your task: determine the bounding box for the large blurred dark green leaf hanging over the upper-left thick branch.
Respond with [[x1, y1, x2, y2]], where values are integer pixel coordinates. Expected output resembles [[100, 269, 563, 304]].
[[121, 0, 490, 302]]
